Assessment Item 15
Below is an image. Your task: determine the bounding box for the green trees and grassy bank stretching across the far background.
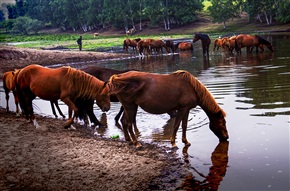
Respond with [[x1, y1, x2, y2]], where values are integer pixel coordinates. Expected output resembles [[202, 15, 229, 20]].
[[0, 0, 290, 50]]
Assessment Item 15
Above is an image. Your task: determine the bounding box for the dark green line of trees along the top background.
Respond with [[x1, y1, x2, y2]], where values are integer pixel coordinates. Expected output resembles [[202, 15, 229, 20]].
[[0, 0, 290, 33]]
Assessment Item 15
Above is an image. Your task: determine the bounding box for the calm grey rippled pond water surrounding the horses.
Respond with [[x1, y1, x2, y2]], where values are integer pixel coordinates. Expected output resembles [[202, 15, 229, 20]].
[[0, 34, 290, 190]]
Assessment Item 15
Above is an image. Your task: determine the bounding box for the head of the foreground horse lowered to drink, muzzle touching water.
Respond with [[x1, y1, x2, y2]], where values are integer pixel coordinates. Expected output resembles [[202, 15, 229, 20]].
[[209, 111, 229, 141]]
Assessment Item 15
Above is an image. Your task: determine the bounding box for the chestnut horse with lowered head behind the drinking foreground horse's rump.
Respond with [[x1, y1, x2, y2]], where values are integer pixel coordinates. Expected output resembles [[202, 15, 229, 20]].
[[16, 64, 110, 128]]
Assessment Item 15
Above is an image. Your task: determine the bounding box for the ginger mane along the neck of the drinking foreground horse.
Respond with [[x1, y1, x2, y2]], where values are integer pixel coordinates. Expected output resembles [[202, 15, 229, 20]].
[[173, 70, 226, 117]]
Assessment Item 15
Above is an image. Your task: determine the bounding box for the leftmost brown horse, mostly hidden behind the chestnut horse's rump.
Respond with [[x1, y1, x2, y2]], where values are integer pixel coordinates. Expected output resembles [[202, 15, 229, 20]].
[[3, 70, 20, 117]]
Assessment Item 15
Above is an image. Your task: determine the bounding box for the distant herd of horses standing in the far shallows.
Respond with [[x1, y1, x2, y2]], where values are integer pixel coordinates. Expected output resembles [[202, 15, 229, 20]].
[[123, 33, 274, 56]]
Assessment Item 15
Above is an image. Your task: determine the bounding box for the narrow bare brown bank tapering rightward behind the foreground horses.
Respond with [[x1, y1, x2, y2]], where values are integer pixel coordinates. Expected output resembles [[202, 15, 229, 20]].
[[0, 46, 129, 77]]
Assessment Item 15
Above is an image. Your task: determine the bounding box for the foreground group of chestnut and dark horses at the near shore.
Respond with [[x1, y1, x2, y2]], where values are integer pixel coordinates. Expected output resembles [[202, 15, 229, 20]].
[[3, 64, 229, 147]]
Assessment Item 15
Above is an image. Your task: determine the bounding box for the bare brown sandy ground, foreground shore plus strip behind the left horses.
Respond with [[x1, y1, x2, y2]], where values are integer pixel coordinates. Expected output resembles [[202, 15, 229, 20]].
[[0, 47, 188, 191]]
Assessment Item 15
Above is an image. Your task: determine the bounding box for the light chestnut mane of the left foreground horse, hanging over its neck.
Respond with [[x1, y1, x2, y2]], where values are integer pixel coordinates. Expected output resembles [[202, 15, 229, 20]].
[[65, 67, 103, 100]]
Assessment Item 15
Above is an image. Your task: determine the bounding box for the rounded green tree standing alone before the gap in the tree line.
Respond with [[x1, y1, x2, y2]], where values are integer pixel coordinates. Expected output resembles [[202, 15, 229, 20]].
[[208, 0, 242, 29]]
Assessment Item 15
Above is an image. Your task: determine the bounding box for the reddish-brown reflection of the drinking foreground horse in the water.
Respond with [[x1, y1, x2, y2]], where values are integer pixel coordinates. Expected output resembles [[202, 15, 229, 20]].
[[177, 141, 229, 191]]
